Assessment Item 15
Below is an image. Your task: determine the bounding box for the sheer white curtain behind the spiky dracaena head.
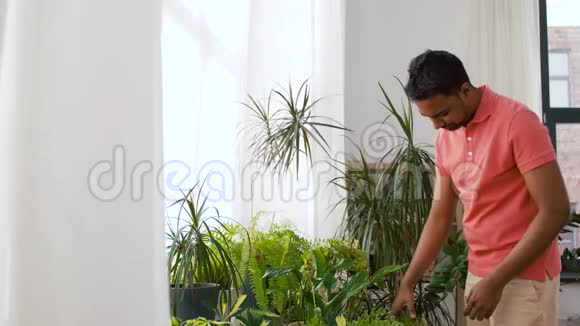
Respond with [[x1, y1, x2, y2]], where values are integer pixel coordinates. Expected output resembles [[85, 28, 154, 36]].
[[240, 0, 345, 238]]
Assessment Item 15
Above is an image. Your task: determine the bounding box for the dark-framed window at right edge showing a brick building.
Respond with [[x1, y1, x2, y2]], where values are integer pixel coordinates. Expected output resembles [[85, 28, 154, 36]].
[[540, 0, 580, 249]]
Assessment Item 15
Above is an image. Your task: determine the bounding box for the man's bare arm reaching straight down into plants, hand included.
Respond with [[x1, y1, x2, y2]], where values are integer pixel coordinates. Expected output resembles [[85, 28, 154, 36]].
[[391, 176, 457, 317]]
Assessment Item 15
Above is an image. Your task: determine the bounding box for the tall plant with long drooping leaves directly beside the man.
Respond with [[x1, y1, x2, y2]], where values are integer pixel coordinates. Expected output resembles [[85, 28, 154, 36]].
[[333, 79, 451, 324]]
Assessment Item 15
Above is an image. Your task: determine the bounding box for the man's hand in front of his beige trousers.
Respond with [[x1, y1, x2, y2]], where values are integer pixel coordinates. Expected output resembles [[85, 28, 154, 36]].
[[464, 277, 505, 320]]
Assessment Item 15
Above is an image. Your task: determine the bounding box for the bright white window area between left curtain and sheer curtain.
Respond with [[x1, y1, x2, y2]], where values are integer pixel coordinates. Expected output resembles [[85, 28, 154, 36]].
[[161, 0, 250, 229]]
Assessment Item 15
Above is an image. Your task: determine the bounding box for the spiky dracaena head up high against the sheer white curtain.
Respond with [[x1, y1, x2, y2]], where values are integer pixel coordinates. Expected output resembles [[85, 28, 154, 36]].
[[242, 79, 348, 174]]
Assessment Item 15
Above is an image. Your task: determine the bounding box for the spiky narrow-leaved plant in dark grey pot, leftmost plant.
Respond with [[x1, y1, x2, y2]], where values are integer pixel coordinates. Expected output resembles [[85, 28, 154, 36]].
[[167, 183, 244, 320]]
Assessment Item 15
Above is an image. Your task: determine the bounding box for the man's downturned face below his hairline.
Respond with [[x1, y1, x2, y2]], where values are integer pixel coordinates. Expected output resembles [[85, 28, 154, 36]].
[[415, 87, 473, 131]]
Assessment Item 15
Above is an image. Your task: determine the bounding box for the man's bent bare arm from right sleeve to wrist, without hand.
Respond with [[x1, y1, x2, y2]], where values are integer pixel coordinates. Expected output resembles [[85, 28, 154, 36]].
[[482, 161, 570, 284]]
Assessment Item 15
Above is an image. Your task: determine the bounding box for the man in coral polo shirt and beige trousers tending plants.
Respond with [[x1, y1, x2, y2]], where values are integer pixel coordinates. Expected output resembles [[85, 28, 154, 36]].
[[392, 50, 570, 326]]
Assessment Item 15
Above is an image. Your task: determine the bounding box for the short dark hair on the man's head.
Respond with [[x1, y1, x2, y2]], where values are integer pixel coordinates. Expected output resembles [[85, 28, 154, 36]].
[[405, 50, 469, 101]]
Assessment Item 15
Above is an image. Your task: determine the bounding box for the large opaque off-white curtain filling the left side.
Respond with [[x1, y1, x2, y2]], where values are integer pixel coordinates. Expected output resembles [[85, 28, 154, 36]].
[[0, 0, 169, 326]]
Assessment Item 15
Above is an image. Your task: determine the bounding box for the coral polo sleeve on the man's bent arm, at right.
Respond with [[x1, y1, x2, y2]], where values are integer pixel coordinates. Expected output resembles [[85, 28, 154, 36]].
[[509, 109, 556, 174]]
